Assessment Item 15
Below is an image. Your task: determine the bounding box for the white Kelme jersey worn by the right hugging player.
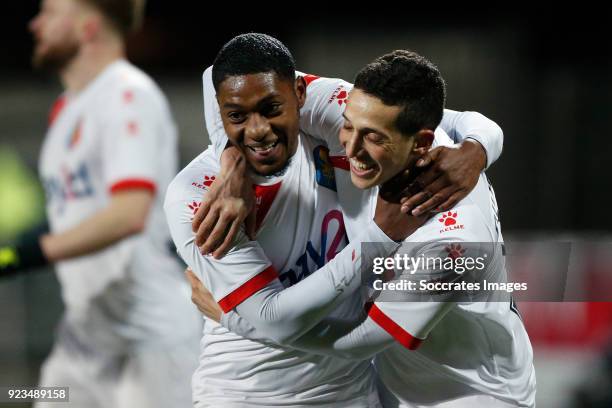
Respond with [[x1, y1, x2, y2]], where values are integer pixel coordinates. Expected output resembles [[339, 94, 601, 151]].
[[369, 142, 535, 407]]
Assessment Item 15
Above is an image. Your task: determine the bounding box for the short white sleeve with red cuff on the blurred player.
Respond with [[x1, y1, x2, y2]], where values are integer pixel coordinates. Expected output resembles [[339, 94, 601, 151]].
[[100, 85, 173, 193]]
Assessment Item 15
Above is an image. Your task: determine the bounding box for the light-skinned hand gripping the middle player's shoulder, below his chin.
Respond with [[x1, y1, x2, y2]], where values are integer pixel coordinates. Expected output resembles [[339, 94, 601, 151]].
[[192, 147, 255, 259]]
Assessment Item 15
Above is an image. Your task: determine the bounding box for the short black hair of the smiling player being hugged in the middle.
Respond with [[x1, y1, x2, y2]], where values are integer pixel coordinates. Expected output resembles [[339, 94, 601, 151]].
[[212, 33, 295, 91]]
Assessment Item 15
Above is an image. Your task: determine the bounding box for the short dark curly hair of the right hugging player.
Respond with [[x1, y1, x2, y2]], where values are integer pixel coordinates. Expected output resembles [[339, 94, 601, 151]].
[[355, 50, 446, 135]]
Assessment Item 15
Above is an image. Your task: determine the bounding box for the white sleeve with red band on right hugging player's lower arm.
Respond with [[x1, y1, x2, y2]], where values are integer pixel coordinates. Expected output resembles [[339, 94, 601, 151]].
[[222, 200, 504, 359]]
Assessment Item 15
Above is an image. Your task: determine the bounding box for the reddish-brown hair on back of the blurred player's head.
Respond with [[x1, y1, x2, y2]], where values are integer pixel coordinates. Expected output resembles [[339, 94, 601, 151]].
[[80, 0, 146, 37]]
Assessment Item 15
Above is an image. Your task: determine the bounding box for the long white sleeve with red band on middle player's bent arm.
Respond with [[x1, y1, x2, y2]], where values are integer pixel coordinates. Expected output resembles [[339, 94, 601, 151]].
[[164, 149, 399, 344]]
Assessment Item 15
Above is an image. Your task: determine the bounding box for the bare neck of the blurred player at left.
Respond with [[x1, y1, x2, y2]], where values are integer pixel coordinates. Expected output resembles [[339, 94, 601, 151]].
[[59, 39, 125, 93]]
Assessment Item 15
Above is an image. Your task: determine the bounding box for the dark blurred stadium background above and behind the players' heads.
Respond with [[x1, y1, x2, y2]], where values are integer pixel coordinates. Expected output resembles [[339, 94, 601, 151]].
[[0, 0, 612, 231]]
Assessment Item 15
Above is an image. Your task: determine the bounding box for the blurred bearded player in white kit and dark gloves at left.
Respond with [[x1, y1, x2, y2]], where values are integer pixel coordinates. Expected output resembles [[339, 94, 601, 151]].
[[0, 0, 201, 408]]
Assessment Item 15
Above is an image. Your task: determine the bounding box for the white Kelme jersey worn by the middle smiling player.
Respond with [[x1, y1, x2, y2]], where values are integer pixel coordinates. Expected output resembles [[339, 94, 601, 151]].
[[165, 136, 373, 407]]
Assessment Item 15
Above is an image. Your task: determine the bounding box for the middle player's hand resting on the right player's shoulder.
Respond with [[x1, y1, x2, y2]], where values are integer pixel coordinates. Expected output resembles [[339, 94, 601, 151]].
[[396, 139, 487, 216]]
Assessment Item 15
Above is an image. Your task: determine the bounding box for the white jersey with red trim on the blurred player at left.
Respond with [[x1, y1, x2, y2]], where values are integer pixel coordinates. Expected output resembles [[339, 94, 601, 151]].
[[39, 60, 199, 348]]
